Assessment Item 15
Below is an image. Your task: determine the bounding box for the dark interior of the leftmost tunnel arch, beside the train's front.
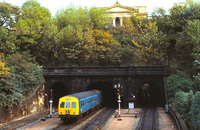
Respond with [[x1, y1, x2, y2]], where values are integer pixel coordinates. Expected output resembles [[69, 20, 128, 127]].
[[49, 83, 69, 108]]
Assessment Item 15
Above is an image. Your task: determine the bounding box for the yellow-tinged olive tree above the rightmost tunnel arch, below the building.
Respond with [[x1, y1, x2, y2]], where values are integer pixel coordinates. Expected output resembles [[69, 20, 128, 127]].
[[132, 21, 168, 65]]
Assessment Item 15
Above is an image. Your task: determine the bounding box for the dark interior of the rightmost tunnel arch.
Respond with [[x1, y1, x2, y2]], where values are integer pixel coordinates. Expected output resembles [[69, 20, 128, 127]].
[[137, 82, 162, 107]]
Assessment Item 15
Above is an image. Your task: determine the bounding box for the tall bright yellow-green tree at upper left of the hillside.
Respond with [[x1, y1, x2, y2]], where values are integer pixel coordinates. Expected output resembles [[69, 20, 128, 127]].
[[17, 0, 51, 60]]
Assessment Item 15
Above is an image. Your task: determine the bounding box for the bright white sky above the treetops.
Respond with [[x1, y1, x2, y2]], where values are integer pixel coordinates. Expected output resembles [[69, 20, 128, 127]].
[[0, 0, 197, 16]]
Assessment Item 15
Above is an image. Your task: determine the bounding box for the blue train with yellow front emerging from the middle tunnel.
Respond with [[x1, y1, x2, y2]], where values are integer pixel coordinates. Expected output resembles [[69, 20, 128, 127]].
[[58, 90, 102, 121]]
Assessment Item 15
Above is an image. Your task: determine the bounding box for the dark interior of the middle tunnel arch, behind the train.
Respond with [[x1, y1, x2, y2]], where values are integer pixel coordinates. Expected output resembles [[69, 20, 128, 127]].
[[87, 82, 117, 107]]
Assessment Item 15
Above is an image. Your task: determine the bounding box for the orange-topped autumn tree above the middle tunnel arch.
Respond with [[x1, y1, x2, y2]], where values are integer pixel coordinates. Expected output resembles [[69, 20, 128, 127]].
[[81, 30, 121, 66]]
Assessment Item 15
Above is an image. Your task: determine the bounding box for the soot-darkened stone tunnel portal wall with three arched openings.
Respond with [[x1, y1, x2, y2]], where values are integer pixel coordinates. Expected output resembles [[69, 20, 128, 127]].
[[43, 65, 170, 108]]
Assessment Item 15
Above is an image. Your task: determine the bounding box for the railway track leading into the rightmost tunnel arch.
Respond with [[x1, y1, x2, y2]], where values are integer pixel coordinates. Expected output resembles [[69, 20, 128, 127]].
[[136, 108, 159, 130]]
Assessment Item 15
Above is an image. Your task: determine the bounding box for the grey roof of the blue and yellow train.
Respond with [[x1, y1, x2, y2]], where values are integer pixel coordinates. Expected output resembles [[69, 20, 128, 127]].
[[61, 90, 101, 99]]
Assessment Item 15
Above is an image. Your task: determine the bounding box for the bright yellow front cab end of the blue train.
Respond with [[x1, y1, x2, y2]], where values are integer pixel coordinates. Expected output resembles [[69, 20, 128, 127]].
[[58, 97, 79, 120]]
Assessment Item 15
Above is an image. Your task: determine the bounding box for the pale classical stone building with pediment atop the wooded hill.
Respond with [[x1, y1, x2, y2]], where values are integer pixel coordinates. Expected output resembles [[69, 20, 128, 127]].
[[107, 1, 147, 27]]
